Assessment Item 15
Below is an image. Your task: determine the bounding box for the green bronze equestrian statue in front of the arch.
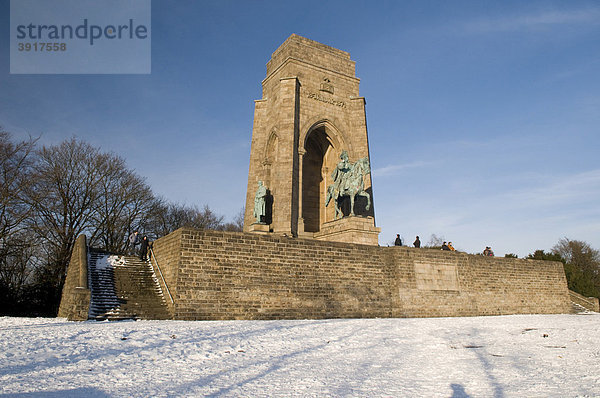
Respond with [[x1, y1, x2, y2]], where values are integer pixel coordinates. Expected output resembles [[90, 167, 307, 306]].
[[325, 150, 371, 220]]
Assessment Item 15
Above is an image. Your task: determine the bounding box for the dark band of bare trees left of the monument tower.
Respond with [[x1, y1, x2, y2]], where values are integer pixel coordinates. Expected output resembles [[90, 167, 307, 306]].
[[0, 129, 243, 316]]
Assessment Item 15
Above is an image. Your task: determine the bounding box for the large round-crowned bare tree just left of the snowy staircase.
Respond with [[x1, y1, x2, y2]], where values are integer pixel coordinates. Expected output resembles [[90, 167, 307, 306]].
[[27, 139, 112, 312]]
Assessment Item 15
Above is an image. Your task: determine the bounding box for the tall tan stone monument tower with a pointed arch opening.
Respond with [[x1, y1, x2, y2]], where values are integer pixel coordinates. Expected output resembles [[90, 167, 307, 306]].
[[244, 34, 380, 245]]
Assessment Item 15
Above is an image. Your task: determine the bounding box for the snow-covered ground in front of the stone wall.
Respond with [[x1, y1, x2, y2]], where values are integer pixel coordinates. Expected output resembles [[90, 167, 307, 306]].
[[0, 314, 600, 398]]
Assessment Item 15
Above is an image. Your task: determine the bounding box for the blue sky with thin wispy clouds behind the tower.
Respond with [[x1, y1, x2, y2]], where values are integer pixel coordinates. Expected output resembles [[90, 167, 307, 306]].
[[0, 0, 600, 256]]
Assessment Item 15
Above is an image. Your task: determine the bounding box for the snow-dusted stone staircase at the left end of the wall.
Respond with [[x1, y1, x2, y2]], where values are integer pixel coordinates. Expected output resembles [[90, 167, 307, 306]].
[[88, 248, 171, 320]]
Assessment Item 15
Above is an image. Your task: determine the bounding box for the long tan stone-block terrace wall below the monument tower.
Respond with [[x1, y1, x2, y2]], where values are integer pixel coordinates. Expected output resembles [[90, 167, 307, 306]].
[[154, 228, 570, 320]]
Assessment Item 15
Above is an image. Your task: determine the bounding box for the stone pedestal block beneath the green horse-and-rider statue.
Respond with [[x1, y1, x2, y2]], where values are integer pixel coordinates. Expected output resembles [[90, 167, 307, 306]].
[[314, 216, 381, 246]]
